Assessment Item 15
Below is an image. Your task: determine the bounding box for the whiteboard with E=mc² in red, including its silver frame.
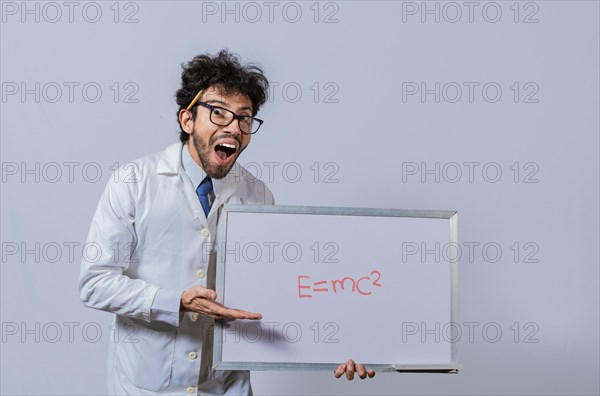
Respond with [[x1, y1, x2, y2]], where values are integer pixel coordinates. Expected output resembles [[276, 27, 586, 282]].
[[213, 204, 460, 372]]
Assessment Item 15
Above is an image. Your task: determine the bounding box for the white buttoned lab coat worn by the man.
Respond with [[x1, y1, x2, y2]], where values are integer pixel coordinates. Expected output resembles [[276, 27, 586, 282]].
[[79, 143, 274, 395]]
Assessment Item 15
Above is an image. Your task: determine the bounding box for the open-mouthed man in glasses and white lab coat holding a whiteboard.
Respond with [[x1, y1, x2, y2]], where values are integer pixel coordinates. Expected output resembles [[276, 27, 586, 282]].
[[79, 51, 374, 394]]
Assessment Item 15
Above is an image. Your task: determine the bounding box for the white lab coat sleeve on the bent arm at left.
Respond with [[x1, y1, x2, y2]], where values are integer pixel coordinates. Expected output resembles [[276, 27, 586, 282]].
[[79, 169, 183, 326]]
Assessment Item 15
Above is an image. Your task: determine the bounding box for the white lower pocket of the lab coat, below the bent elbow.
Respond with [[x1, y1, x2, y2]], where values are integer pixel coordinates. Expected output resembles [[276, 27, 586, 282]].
[[115, 316, 176, 392]]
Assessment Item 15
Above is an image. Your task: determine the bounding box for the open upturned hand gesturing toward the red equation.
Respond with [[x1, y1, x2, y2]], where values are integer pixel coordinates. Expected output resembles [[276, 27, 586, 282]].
[[181, 286, 262, 320]]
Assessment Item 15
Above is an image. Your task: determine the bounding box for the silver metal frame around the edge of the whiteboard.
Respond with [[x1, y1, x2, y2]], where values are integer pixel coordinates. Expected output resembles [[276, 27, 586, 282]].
[[213, 204, 462, 374]]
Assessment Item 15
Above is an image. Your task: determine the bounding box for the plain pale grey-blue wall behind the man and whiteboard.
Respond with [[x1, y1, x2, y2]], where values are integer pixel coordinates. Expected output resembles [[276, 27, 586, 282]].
[[0, 1, 600, 394]]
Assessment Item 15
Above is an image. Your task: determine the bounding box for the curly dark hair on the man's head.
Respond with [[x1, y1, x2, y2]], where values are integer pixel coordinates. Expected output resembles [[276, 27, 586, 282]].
[[175, 49, 269, 143]]
